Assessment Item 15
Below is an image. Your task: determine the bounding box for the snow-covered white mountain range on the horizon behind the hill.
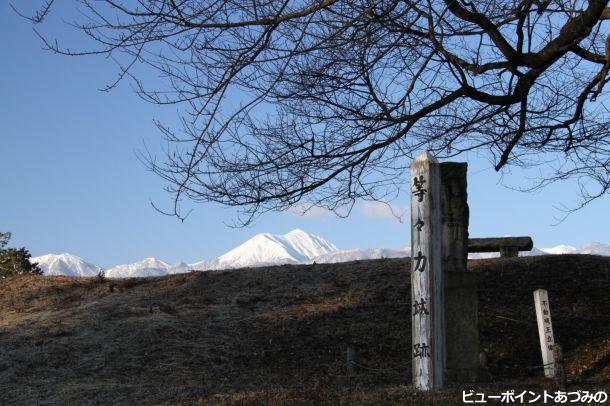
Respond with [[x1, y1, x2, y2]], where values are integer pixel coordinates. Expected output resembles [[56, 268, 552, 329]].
[[31, 229, 610, 278]]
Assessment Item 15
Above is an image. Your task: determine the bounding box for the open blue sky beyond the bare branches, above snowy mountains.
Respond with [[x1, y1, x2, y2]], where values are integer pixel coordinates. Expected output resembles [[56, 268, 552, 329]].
[[0, 1, 610, 266]]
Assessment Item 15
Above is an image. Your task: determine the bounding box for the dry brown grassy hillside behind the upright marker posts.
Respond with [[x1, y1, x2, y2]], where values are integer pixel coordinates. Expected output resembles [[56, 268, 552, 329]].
[[0, 255, 610, 405]]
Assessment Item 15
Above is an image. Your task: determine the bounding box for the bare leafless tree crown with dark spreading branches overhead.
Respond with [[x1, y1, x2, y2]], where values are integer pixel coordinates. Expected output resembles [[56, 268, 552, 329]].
[[21, 0, 610, 223]]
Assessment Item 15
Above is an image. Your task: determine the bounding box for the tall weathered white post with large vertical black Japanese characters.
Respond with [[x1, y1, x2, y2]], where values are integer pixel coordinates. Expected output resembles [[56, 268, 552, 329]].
[[411, 151, 445, 390]]
